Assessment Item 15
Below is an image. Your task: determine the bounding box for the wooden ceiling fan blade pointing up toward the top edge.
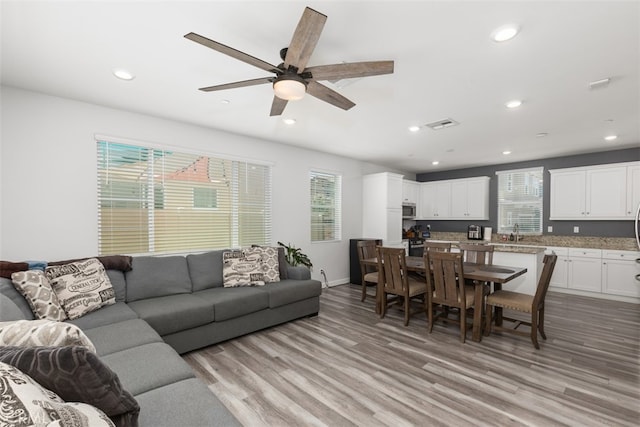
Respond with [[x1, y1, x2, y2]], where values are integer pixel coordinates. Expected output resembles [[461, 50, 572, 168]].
[[284, 7, 327, 73]]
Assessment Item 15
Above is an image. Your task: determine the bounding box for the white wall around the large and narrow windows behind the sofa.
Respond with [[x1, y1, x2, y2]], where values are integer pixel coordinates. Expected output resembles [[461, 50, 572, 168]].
[[0, 87, 404, 284]]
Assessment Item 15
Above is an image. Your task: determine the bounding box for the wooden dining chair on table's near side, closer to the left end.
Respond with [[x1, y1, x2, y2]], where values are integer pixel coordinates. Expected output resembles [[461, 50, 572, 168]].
[[377, 246, 427, 326]]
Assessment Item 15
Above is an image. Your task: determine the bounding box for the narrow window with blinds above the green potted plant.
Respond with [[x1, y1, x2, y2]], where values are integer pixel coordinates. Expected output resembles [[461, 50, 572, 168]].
[[309, 171, 342, 242]]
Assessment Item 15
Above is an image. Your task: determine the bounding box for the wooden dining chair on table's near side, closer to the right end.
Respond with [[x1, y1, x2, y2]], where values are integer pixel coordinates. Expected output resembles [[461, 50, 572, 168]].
[[424, 251, 475, 343]]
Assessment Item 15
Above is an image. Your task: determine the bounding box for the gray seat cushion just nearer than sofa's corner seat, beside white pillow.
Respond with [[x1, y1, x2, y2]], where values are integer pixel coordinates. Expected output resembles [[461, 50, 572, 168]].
[[84, 319, 162, 356]]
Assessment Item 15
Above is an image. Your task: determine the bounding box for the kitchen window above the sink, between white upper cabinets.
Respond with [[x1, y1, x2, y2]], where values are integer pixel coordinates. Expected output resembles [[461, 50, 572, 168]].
[[496, 168, 543, 234]]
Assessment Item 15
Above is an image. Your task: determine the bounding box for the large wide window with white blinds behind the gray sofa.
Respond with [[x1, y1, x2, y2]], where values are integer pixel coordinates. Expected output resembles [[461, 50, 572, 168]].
[[97, 141, 271, 255]]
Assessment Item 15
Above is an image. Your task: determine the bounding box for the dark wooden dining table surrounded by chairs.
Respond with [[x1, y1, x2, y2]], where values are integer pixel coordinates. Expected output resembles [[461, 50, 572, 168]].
[[363, 256, 527, 342]]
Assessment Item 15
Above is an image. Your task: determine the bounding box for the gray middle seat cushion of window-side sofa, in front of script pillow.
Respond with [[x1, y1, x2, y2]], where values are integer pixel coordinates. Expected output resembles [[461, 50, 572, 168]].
[[193, 287, 269, 322]]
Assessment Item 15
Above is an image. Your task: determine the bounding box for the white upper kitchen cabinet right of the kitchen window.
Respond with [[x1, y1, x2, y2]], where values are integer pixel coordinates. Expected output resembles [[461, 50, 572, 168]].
[[549, 162, 640, 220]]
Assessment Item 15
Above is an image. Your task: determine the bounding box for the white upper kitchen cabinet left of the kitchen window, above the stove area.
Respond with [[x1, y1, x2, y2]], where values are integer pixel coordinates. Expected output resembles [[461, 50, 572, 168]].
[[418, 176, 489, 220]]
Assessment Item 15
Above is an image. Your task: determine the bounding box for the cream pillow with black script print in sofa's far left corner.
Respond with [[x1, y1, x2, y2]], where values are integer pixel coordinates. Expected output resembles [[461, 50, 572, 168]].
[[44, 258, 116, 319]]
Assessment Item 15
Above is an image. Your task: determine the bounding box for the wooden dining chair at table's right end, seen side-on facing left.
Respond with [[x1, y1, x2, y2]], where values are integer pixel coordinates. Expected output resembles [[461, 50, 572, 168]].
[[485, 254, 558, 349]]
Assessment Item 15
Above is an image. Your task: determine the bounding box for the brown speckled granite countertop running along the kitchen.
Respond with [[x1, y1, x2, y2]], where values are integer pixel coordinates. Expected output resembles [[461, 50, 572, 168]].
[[429, 232, 638, 253]]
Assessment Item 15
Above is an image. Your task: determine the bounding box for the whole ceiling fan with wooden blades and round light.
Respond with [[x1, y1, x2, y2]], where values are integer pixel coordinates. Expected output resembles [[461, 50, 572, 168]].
[[185, 7, 393, 116]]
